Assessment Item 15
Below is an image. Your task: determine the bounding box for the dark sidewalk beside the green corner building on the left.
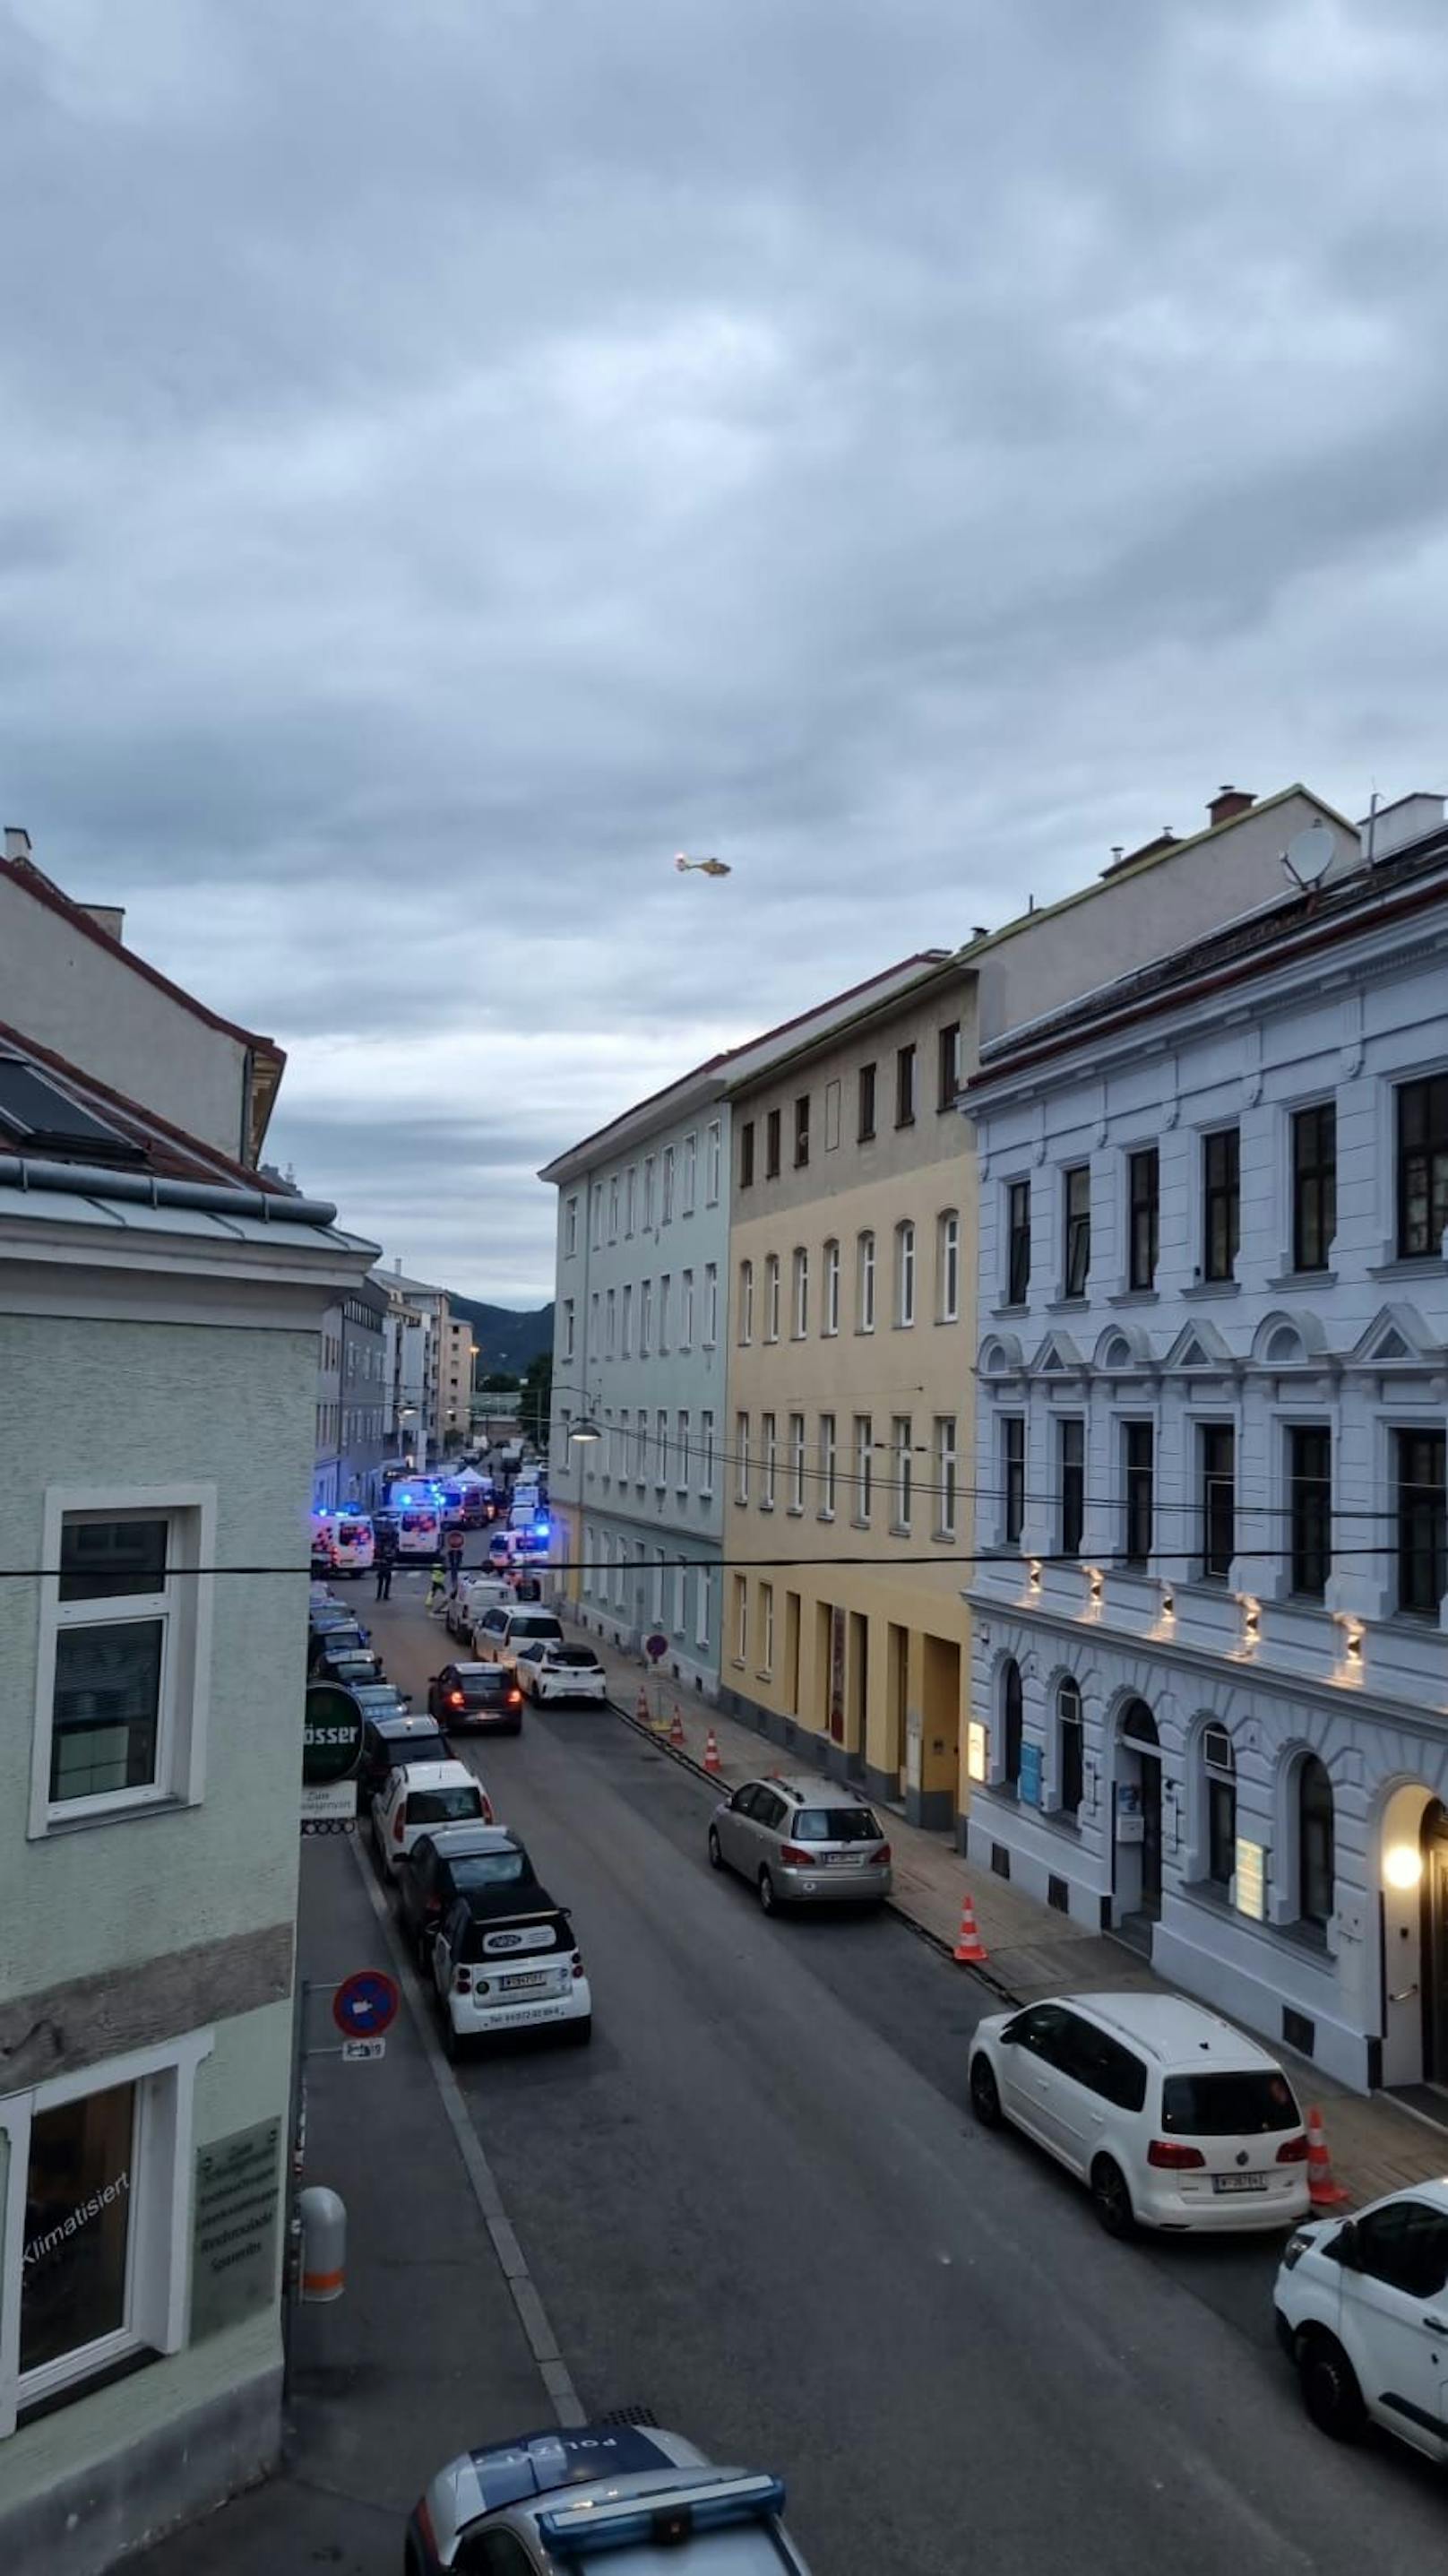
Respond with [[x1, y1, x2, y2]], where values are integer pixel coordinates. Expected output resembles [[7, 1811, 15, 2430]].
[[126, 1837, 554, 2576]]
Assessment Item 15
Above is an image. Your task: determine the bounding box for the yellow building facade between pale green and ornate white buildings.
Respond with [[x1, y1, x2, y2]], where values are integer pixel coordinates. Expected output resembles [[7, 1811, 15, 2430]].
[[719, 953, 977, 1831]]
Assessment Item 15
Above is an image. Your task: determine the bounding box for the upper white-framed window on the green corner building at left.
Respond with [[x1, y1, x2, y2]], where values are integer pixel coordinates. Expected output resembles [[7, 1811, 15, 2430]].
[[31, 1489, 214, 1834]]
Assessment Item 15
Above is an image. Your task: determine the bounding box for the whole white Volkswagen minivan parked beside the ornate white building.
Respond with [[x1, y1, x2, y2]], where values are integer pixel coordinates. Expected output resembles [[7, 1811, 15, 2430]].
[[969, 1993, 1309, 2236]]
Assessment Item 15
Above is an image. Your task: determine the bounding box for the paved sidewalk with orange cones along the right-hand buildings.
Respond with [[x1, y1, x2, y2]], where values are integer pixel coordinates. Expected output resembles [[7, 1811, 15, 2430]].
[[559, 1603, 1448, 2205]]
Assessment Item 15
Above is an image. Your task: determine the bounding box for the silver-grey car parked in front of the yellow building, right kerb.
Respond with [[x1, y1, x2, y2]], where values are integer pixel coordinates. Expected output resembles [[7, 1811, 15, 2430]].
[[709, 1772, 892, 1914]]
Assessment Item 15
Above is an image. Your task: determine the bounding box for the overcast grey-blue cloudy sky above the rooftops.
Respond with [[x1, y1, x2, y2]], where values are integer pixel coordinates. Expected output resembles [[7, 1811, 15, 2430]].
[[0, 0, 1448, 1303]]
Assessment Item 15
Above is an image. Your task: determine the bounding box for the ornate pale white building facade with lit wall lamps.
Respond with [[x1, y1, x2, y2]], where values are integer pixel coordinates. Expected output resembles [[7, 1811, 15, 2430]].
[[966, 799, 1448, 2087]]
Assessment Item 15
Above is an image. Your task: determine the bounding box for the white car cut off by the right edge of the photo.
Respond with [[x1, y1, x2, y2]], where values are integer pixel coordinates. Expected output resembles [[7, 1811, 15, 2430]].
[[1272, 2179, 1448, 2460]]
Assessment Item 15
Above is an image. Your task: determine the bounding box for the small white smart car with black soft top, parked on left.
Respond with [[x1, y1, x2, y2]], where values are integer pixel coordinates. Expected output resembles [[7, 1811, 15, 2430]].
[[433, 1886, 592, 2055]]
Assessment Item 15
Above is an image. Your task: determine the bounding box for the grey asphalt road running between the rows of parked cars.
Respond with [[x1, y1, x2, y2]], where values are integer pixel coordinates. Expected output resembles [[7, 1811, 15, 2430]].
[[363, 1551, 1443, 2576]]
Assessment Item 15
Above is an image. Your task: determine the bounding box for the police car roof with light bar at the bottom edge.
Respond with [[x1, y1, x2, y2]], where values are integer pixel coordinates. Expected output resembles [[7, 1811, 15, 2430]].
[[404, 2422, 809, 2576]]
